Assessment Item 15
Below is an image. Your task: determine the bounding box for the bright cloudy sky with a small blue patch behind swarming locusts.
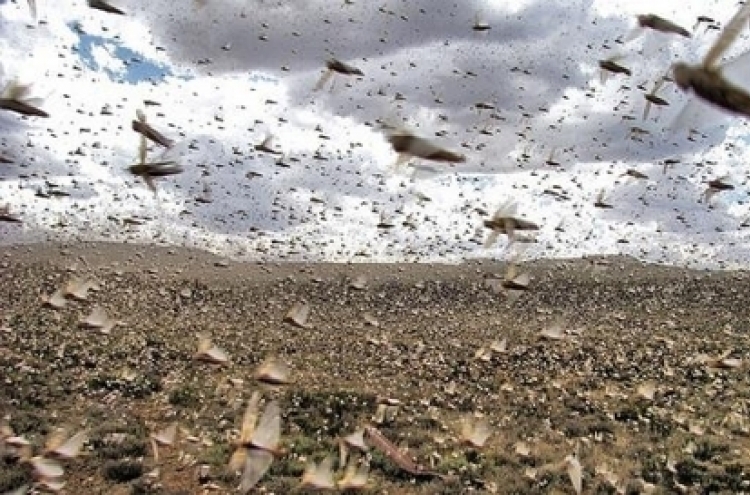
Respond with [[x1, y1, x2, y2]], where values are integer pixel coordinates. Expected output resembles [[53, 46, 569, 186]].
[[0, 0, 750, 269]]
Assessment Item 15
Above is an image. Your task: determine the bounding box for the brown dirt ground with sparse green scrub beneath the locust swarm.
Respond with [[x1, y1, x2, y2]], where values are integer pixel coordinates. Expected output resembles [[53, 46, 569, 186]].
[[0, 244, 750, 494]]
